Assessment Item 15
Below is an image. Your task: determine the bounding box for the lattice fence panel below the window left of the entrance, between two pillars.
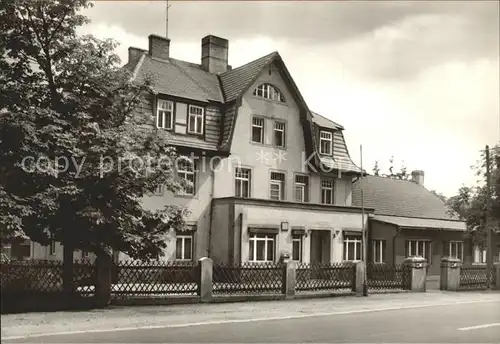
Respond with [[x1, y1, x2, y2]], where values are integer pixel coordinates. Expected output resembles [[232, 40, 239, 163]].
[[212, 262, 284, 294]]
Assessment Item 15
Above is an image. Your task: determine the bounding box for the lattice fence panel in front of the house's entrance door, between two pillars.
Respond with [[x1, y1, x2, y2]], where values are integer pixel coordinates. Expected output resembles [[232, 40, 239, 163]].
[[295, 262, 356, 292]]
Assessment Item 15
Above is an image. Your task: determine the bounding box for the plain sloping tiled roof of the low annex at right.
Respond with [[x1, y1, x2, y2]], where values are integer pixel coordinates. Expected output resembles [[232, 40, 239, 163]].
[[352, 176, 457, 220]]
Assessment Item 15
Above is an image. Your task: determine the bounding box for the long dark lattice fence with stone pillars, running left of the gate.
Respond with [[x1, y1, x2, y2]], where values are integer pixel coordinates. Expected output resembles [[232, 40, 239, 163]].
[[1, 258, 425, 311]]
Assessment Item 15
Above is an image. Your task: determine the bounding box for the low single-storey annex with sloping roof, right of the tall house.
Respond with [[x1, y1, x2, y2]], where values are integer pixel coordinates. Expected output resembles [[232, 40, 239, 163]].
[[353, 171, 499, 276]]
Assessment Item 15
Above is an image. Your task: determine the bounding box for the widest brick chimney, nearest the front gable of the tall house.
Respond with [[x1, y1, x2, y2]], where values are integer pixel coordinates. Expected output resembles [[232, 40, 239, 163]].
[[201, 35, 229, 74]]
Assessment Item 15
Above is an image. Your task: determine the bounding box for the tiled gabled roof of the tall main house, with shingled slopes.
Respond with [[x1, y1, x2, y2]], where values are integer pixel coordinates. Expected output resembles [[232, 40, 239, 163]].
[[125, 45, 360, 172]]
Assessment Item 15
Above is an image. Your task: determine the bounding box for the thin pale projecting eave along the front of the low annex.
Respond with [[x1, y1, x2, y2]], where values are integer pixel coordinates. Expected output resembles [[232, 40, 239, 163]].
[[372, 215, 466, 232]]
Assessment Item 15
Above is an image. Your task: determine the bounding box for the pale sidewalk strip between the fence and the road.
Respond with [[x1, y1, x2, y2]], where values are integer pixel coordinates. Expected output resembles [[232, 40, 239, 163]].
[[1, 291, 500, 339]]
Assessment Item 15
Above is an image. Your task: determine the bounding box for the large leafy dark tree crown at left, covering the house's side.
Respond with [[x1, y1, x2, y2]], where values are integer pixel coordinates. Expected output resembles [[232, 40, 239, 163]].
[[0, 0, 185, 272]]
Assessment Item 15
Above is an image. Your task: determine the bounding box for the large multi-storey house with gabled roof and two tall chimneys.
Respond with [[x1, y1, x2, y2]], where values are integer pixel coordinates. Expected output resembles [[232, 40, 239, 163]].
[[11, 35, 373, 263]]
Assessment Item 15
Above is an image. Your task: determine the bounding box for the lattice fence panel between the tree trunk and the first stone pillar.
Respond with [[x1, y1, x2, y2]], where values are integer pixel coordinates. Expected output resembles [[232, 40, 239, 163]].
[[111, 261, 200, 299]]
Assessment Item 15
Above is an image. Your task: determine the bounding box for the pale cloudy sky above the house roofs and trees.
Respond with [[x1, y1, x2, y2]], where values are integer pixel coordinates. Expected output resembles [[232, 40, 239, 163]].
[[80, 0, 500, 196]]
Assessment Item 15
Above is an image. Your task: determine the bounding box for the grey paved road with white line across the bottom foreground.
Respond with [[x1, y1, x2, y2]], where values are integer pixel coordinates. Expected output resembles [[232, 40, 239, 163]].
[[2, 299, 500, 343]]
